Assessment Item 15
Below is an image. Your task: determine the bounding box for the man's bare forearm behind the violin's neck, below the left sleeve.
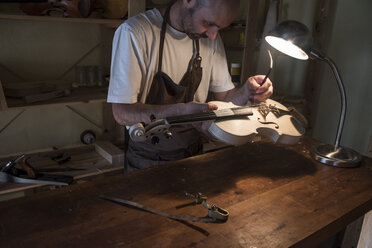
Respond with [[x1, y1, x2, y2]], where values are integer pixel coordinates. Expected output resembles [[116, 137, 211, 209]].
[[112, 102, 214, 125]]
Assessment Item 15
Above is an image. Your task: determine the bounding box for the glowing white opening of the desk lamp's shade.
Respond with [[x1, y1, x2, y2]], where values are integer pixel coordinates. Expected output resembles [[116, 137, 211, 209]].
[[265, 36, 309, 60]]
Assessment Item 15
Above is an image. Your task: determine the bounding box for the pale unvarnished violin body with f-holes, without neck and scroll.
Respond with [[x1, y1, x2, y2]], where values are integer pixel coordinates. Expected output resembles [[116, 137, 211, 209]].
[[202, 99, 305, 146]]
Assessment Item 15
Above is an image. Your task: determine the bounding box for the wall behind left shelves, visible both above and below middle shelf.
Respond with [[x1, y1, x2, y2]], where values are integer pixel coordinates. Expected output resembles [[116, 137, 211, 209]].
[[0, 5, 108, 156]]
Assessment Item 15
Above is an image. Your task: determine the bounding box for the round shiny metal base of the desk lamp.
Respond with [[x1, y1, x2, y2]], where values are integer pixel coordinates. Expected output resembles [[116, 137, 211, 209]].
[[310, 144, 362, 167]]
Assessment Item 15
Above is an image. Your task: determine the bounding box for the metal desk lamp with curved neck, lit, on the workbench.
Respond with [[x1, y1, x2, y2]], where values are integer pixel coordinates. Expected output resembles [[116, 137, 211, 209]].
[[265, 20, 361, 167]]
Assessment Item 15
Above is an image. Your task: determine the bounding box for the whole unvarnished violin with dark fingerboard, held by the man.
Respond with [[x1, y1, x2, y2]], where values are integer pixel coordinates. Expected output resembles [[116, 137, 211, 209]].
[[129, 99, 306, 146]]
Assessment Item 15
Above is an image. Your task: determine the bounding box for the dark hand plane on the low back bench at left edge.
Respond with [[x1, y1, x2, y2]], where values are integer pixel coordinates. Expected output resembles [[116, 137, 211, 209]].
[[0, 154, 74, 185]]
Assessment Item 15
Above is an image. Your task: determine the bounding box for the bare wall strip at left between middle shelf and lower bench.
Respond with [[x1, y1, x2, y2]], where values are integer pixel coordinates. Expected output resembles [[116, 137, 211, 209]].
[[0, 103, 102, 156]]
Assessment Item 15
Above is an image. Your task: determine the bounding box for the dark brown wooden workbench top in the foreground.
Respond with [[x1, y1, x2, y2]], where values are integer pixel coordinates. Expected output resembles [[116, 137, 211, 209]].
[[0, 138, 372, 247]]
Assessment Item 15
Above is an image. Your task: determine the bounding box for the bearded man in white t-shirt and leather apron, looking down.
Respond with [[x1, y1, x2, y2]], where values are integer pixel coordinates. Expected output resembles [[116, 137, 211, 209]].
[[107, 0, 273, 171]]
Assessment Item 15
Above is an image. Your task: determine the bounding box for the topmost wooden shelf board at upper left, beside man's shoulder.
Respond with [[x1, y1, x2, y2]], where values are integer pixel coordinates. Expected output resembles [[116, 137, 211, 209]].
[[0, 14, 125, 27]]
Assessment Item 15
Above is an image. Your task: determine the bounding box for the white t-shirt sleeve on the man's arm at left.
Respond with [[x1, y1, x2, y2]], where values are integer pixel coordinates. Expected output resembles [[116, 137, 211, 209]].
[[107, 23, 144, 103]]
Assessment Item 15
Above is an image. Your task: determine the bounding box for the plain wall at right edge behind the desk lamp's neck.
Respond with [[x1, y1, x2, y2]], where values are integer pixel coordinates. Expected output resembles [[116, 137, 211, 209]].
[[312, 0, 372, 154]]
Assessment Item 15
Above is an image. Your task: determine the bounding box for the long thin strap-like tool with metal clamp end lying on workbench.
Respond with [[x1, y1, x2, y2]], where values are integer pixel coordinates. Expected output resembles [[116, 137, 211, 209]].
[[99, 193, 229, 223]]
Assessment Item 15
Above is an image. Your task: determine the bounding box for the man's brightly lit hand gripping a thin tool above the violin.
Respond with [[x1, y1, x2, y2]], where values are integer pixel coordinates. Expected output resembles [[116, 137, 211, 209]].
[[244, 75, 274, 102]]
